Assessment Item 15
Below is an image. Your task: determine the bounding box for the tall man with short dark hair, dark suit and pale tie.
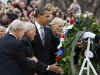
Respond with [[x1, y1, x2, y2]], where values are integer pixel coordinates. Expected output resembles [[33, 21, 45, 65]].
[[32, 9, 60, 75]]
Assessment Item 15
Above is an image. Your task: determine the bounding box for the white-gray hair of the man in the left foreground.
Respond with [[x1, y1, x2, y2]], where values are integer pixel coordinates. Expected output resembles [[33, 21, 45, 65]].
[[7, 19, 26, 32]]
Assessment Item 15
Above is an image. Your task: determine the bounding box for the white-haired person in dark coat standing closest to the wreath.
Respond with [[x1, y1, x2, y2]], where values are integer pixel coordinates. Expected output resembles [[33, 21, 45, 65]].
[[50, 17, 65, 62]]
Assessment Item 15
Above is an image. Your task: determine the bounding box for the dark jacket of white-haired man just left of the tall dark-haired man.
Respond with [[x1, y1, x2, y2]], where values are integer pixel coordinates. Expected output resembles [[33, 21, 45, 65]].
[[22, 35, 47, 75]]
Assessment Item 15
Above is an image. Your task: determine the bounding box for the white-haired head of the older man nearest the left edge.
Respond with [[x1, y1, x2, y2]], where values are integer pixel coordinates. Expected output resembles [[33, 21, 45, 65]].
[[8, 19, 26, 40]]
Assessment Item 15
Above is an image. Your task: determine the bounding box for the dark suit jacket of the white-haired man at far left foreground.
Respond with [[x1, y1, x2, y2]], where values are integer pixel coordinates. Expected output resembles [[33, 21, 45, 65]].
[[0, 34, 25, 75]]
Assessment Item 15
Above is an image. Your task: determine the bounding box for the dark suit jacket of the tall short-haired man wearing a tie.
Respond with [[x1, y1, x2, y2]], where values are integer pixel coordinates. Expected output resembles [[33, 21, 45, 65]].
[[32, 24, 59, 75]]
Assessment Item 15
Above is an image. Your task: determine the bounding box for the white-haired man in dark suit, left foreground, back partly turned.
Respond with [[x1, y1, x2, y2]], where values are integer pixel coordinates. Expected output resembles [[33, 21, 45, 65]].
[[0, 20, 25, 75]]
